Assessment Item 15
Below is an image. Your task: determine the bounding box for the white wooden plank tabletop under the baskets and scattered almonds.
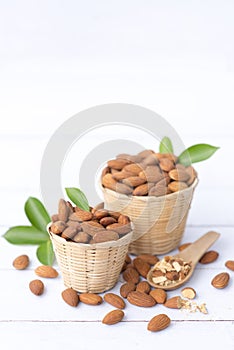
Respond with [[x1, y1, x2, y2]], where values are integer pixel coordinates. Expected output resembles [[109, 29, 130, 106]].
[[0, 226, 234, 350]]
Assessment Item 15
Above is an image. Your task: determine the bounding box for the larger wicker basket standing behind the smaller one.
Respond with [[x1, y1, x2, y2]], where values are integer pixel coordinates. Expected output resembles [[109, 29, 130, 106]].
[[102, 179, 198, 255]]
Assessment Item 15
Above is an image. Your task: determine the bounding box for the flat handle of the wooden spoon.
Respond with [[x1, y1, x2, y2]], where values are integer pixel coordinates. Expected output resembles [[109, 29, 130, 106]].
[[177, 231, 220, 264]]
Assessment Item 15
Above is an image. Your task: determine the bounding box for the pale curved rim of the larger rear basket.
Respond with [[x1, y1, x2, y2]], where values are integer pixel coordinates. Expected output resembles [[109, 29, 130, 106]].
[[100, 177, 199, 202]]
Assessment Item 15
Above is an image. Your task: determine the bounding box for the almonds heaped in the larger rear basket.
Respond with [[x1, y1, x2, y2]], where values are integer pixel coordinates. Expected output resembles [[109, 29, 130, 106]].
[[102, 150, 197, 197]]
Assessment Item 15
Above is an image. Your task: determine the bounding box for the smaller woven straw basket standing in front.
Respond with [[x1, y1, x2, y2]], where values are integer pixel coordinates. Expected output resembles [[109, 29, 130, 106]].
[[50, 228, 132, 293]]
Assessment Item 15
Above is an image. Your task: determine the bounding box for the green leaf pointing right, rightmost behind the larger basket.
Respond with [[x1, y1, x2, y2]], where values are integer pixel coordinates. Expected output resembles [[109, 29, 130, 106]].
[[179, 143, 219, 166]]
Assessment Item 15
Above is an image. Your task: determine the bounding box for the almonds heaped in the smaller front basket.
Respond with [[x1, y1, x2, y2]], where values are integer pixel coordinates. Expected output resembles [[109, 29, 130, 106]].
[[50, 199, 132, 244]]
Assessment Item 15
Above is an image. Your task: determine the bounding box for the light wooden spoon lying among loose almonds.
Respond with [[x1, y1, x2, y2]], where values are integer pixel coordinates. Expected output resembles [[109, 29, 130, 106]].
[[147, 231, 220, 290]]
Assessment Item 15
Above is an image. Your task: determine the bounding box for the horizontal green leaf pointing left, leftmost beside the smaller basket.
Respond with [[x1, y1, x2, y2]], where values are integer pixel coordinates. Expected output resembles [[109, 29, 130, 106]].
[[3, 226, 49, 244]]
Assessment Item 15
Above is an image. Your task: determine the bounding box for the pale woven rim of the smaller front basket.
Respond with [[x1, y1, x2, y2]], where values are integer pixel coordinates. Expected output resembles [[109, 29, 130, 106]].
[[47, 222, 133, 249]]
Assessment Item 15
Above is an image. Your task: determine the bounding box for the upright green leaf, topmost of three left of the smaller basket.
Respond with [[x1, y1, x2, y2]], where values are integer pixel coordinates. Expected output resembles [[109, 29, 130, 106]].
[[24, 197, 51, 232]]
